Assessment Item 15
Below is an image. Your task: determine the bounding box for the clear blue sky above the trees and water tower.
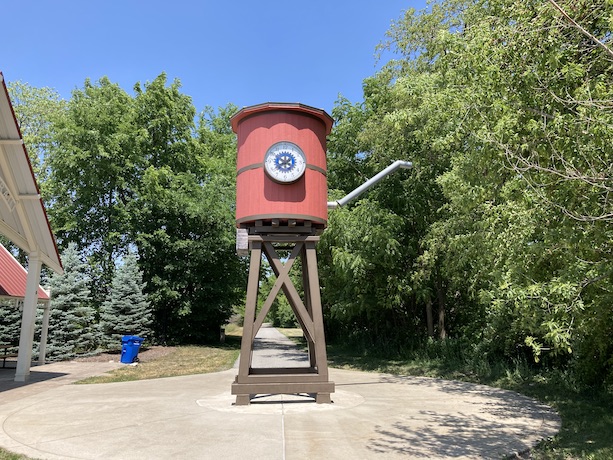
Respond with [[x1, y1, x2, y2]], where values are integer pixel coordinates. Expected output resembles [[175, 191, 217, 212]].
[[0, 0, 425, 112]]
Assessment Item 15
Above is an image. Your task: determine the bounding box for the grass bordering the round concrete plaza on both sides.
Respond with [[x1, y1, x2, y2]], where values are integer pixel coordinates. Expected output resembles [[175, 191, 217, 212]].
[[0, 327, 613, 460]]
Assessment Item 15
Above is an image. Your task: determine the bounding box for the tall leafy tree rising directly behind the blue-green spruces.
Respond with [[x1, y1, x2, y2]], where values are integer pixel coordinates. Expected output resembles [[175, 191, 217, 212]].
[[47, 77, 142, 302]]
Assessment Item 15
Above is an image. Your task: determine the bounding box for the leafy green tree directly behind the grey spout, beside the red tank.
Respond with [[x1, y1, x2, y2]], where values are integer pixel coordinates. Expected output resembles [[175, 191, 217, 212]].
[[320, 61, 459, 349]]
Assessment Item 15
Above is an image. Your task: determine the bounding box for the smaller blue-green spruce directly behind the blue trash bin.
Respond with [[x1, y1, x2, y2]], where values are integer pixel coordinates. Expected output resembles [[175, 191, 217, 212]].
[[100, 253, 152, 348]]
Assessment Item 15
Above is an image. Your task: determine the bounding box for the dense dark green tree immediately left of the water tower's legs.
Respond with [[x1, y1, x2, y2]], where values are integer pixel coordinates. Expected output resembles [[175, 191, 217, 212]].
[[137, 168, 244, 343]]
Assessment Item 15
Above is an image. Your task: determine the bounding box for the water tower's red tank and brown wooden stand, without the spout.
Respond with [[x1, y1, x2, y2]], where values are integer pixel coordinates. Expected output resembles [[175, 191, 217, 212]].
[[231, 103, 334, 405]]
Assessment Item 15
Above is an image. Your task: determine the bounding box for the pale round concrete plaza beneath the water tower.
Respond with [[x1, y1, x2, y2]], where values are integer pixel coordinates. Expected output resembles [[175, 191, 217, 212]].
[[0, 328, 560, 460]]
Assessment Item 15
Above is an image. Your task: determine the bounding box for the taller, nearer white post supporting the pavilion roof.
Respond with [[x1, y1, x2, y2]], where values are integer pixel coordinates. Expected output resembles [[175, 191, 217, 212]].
[[15, 252, 41, 382]]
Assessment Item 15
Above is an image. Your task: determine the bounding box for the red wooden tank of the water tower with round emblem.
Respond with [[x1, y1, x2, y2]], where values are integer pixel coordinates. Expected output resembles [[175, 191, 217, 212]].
[[231, 103, 333, 228]]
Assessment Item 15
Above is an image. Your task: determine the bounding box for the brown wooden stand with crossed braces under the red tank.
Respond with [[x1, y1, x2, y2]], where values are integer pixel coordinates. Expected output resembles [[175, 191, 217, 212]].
[[232, 221, 334, 405]]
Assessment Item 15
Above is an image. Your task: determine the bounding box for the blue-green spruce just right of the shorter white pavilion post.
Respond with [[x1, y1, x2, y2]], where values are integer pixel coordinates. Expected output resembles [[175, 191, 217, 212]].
[[47, 243, 99, 361]]
